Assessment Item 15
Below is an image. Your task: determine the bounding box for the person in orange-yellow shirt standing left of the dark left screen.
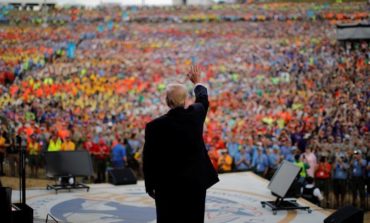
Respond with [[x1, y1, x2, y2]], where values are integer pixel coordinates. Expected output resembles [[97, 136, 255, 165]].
[[27, 135, 41, 178]]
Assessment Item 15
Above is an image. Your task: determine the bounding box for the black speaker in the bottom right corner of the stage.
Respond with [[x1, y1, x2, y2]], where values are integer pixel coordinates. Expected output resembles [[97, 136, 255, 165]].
[[324, 206, 364, 223]]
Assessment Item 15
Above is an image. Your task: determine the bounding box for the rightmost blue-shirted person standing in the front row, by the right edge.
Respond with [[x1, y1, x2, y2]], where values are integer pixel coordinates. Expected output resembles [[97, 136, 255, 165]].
[[351, 150, 367, 208]]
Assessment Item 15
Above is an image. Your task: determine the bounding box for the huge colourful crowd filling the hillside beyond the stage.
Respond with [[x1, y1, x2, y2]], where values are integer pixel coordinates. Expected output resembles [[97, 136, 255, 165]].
[[0, 3, 370, 207]]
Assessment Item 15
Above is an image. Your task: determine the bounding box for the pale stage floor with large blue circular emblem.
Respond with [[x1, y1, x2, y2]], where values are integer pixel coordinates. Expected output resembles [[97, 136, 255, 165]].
[[13, 172, 329, 223]]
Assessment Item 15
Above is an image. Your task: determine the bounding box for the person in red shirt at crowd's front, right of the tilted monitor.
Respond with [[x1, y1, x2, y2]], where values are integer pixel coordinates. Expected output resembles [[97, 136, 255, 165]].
[[315, 156, 331, 205]]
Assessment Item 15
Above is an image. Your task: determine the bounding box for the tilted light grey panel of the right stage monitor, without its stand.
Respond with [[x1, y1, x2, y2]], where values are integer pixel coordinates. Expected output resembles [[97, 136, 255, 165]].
[[268, 161, 301, 198]]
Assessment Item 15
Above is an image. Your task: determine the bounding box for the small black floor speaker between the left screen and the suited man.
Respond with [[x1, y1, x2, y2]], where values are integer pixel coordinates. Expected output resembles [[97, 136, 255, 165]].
[[108, 168, 137, 185]]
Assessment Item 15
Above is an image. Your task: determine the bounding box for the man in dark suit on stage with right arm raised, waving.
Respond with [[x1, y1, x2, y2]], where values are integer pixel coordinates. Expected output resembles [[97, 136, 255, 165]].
[[143, 67, 219, 223]]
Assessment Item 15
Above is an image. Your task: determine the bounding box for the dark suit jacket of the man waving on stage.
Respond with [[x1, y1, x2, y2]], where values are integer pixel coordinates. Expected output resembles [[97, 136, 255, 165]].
[[143, 85, 219, 192]]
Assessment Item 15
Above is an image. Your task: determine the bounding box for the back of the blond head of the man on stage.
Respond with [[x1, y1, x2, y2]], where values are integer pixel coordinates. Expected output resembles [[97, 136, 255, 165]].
[[166, 84, 187, 108]]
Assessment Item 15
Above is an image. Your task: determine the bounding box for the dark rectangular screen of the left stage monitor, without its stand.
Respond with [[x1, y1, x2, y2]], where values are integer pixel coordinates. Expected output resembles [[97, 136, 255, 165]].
[[45, 151, 93, 177]]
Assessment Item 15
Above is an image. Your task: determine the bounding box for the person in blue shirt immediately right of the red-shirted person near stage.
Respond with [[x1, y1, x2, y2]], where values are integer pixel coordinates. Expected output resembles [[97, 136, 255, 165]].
[[332, 155, 349, 207]]
